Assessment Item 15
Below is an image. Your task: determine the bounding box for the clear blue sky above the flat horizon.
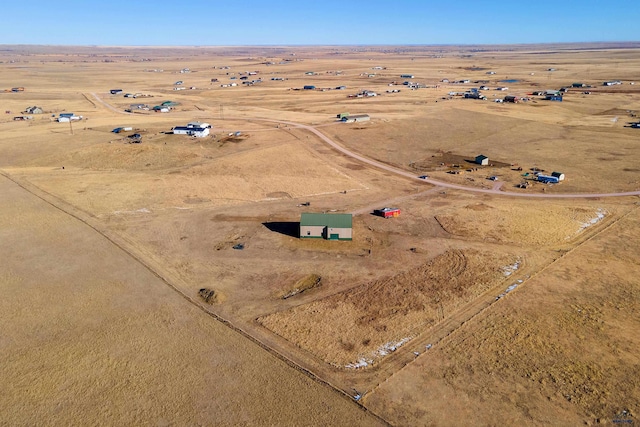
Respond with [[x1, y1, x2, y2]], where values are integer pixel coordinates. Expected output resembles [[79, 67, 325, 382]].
[[0, 0, 640, 46]]
